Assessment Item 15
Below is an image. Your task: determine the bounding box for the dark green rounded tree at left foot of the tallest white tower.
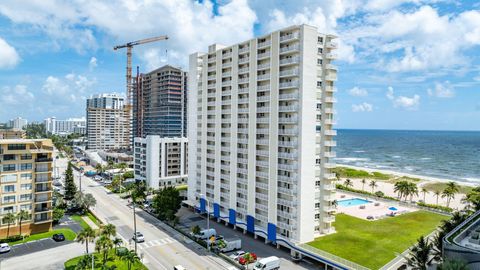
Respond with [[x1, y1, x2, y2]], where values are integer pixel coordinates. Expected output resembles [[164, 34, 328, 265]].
[[152, 187, 182, 220]]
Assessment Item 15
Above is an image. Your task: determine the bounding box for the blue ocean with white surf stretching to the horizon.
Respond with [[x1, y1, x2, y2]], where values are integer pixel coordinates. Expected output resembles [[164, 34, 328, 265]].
[[335, 129, 480, 184]]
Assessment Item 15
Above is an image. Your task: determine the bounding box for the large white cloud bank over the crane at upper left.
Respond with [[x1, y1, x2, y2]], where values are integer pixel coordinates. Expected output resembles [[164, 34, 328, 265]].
[[0, 0, 257, 66]]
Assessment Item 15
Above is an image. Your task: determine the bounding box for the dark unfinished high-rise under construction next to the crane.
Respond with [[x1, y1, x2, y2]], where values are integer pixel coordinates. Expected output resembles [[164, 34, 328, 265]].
[[133, 65, 187, 138]]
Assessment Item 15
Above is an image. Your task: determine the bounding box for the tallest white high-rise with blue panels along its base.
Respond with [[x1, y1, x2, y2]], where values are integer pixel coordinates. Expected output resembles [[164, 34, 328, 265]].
[[187, 25, 337, 245]]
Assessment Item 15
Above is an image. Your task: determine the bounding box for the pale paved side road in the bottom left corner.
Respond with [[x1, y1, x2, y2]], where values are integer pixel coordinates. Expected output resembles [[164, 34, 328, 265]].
[[0, 243, 85, 270]]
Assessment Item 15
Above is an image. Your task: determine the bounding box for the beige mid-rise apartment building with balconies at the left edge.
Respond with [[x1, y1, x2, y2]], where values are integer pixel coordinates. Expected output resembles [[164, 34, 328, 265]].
[[0, 139, 53, 238]]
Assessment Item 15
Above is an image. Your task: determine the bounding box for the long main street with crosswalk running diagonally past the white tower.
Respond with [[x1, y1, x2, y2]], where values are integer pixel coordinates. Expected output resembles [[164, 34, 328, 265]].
[[56, 154, 236, 270]]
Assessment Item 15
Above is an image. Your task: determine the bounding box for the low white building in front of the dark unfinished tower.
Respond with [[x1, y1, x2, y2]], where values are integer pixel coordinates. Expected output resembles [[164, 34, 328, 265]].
[[134, 135, 188, 189]]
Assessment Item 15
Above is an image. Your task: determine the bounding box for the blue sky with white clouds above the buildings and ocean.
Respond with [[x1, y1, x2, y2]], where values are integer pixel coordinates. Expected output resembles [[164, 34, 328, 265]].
[[0, 0, 480, 130]]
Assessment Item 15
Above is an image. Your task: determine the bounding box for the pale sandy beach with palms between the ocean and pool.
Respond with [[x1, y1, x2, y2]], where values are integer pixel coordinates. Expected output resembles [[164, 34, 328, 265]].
[[338, 164, 475, 210]]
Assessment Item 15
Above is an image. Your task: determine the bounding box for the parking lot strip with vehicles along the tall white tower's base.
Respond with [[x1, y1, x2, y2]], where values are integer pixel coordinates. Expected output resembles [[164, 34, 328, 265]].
[[179, 207, 319, 269]]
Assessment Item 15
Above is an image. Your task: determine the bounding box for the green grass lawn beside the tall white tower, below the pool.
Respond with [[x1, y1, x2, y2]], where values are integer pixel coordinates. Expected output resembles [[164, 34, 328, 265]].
[[308, 211, 447, 269]]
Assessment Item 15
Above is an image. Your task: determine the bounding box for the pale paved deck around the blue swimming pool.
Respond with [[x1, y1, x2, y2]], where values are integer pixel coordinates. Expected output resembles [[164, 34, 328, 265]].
[[336, 191, 417, 220]]
